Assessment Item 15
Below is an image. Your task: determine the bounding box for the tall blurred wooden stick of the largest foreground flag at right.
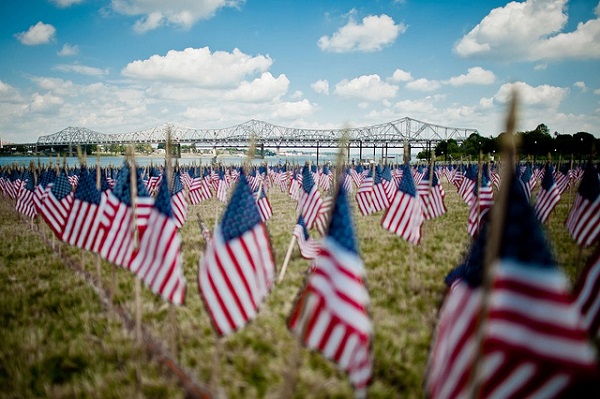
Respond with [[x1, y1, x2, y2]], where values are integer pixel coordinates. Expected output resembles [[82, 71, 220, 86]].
[[467, 90, 518, 398]]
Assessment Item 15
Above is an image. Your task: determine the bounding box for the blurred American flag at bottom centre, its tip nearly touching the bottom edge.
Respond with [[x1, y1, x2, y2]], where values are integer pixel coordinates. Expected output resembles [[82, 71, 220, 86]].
[[287, 185, 373, 397]]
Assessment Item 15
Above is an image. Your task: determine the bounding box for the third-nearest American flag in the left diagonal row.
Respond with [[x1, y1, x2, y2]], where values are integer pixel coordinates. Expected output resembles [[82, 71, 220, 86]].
[[62, 168, 105, 251]]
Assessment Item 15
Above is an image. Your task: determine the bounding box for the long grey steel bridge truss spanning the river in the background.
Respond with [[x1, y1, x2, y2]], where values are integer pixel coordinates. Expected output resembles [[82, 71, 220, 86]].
[[37, 117, 478, 148]]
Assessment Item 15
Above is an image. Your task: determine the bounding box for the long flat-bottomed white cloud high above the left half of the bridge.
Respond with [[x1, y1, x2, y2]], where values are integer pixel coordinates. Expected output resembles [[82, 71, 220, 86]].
[[121, 47, 273, 88]]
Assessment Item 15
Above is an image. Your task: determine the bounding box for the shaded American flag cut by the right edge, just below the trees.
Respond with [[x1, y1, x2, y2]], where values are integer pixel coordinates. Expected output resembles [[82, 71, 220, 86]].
[[565, 163, 600, 247]]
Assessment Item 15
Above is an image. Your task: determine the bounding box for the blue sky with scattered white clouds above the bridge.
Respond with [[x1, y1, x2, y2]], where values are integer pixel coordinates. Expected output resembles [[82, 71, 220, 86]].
[[0, 0, 600, 143]]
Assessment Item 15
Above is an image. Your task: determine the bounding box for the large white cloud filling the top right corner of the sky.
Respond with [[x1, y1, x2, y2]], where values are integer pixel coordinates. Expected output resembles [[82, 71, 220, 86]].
[[454, 0, 600, 61]]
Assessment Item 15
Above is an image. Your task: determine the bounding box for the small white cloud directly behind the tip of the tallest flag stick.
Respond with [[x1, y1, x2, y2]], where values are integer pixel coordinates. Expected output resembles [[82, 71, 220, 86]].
[[494, 82, 569, 110]]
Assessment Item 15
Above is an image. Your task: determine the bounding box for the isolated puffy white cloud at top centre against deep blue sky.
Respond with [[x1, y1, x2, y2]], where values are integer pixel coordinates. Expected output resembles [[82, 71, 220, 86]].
[[317, 14, 406, 53]]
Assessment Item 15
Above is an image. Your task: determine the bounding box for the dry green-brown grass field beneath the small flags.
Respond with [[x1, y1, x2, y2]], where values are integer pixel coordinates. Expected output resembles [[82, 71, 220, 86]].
[[0, 180, 592, 398]]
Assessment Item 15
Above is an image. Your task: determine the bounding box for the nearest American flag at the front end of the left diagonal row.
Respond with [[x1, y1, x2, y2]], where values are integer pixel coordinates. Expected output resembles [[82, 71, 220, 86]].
[[129, 179, 186, 305]]
